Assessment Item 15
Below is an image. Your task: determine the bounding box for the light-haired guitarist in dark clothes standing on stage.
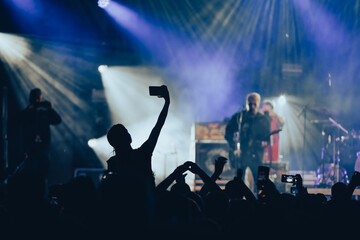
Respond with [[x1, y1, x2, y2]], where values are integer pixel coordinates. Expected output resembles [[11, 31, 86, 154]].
[[225, 92, 270, 192]]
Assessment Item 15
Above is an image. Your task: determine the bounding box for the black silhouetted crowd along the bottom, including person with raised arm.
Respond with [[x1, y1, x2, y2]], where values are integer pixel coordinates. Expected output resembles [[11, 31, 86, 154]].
[[0, 86, 360, 239]]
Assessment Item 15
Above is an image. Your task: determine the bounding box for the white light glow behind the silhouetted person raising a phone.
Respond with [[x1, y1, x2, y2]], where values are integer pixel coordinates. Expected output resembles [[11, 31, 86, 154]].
[[92, 67, 194, 186]]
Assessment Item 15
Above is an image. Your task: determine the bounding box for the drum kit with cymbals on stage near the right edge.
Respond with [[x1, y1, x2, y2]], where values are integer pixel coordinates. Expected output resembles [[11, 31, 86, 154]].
[[311, 109, 360, 188]]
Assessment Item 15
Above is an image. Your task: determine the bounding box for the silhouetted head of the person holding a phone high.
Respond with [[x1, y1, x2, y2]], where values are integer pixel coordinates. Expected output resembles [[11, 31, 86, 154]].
[[107, 124, 132, 149]]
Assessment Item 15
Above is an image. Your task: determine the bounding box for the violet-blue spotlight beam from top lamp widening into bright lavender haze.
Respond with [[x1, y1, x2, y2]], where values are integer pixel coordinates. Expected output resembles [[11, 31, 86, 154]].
[[104, 2, 249, 121]]
